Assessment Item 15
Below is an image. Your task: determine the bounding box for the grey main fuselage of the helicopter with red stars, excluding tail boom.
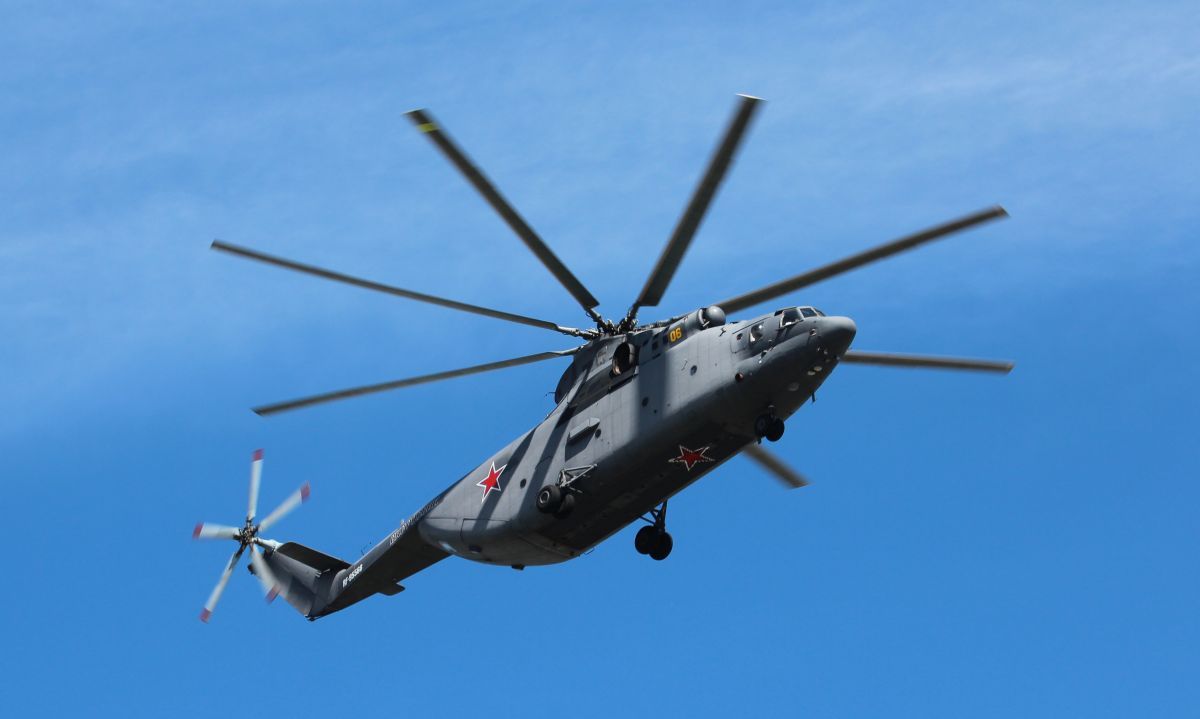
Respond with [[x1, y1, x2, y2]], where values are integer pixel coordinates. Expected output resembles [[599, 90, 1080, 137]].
[[417, 307, 854, 567]]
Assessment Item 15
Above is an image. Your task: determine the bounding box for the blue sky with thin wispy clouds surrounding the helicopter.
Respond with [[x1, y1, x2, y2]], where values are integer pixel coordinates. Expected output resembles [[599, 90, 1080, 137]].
[[0, 2, 1200, 717]]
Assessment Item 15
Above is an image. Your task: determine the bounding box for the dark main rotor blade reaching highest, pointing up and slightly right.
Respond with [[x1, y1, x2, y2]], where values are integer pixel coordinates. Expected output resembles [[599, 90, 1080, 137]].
[[629, 95, 762, 318]]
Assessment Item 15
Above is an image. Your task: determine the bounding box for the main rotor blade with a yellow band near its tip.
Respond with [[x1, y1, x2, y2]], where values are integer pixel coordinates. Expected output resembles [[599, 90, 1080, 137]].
[[404, 109, 601, 322]]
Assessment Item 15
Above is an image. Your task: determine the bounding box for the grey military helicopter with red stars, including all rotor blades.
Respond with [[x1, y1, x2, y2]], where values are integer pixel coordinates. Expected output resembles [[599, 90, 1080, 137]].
[[193, 95, 1013, 621]]
